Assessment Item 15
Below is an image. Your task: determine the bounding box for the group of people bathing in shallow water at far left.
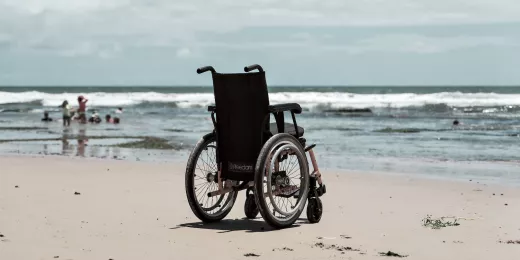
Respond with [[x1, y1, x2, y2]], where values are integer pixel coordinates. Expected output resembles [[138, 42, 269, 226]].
[[42, 96, 123, 126]]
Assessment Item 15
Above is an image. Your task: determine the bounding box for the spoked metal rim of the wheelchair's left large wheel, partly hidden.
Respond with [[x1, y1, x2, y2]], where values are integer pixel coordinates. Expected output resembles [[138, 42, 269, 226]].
[[192, 141, 234, 217]]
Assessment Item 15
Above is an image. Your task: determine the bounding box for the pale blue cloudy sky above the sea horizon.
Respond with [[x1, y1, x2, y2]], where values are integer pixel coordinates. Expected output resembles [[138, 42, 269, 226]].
[[0, 0, 520, 86]]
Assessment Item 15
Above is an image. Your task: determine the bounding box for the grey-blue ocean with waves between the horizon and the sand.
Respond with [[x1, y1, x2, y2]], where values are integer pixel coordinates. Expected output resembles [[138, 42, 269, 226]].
[[0, 86, 520, 184]]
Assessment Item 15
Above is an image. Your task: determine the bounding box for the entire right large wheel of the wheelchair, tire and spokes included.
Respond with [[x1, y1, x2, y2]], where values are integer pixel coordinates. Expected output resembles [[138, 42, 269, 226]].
[[254, 133, 309, 228]]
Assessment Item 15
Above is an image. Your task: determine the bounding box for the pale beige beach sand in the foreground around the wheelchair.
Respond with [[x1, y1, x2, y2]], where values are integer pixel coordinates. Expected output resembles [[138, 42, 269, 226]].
[[0, 156, 520, 260]]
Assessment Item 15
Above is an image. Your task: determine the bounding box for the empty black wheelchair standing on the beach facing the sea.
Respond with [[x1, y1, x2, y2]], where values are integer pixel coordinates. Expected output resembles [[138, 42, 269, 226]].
[[185, 64, 326, 229]]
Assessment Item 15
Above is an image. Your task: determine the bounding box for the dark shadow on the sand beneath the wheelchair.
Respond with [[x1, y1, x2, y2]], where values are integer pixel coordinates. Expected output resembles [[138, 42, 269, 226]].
[[175, 218, 305, 233]]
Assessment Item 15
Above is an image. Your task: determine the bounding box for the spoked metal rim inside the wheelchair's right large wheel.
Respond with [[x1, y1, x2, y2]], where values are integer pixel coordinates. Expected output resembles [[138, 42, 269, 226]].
[[264, 141, 308, 221]]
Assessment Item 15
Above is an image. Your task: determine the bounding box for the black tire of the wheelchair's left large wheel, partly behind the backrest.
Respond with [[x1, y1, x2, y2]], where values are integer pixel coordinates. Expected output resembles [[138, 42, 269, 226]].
[[185, 135, 237, 223]]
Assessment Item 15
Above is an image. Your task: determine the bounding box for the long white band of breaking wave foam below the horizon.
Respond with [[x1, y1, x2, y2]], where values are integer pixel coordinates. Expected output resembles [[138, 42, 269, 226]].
[[0, 91, 520, 109]]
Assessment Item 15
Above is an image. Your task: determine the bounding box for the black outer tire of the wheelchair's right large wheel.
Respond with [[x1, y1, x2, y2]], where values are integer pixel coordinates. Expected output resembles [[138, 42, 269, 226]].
[[254, 133, 309, 229]]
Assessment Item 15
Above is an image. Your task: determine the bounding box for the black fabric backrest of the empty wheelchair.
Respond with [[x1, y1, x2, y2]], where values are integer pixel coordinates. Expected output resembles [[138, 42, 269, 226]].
[[213, 71, 269, 181]]
